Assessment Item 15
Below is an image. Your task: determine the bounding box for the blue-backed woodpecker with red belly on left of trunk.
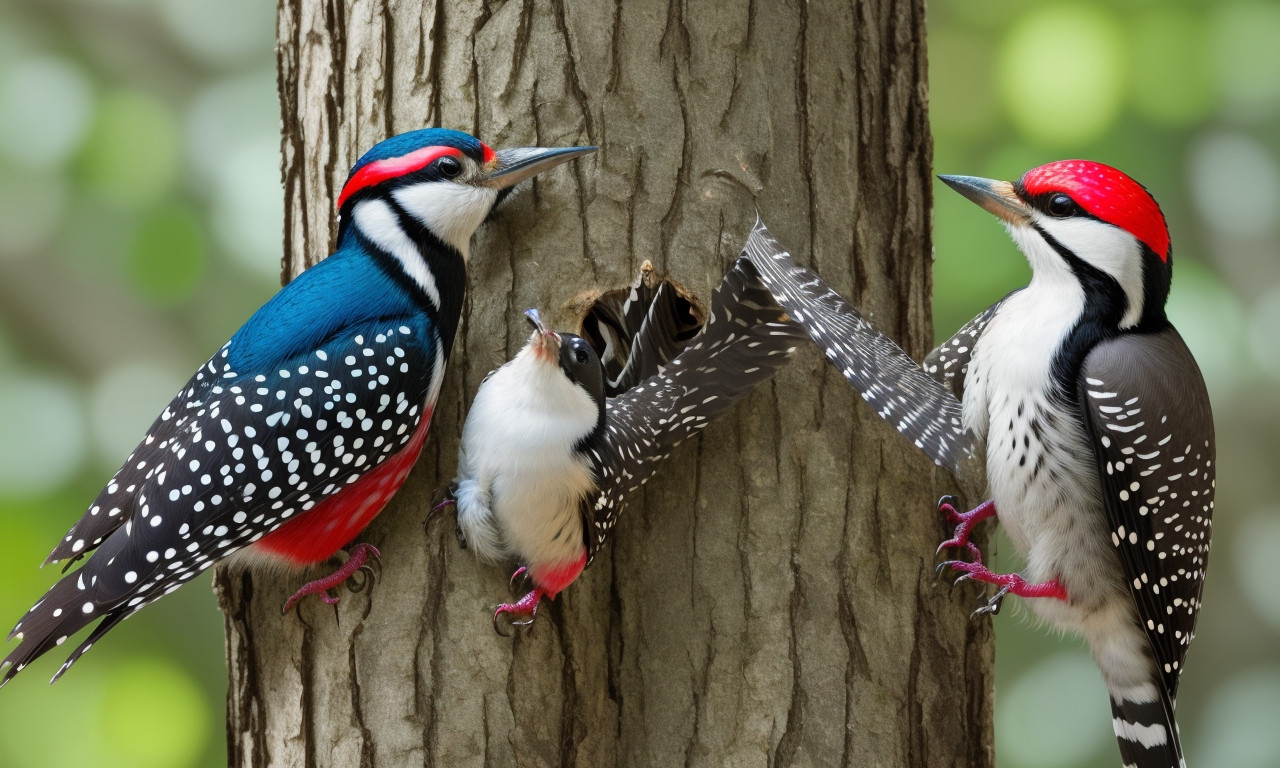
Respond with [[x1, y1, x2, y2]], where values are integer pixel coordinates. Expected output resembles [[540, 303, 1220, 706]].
[[0, 128, 594, 685]]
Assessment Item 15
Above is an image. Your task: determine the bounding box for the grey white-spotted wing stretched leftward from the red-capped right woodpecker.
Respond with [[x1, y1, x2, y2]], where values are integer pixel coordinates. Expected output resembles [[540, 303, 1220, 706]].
[[745, 220, 974, 475]]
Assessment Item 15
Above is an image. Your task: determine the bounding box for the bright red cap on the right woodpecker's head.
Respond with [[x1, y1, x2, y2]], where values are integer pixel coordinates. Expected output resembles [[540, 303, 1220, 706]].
[[1021, 160, 1169, 261]]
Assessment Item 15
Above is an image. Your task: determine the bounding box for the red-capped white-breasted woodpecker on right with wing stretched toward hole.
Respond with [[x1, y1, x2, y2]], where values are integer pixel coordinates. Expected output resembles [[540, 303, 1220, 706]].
[[760, 160, 1216, 768]]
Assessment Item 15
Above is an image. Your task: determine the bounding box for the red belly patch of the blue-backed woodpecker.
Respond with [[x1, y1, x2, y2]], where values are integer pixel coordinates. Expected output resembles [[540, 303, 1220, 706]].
[[253, 408, 433, 566]]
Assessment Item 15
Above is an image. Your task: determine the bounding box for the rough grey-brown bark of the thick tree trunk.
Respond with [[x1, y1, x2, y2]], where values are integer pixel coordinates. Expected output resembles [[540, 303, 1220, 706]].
[[218, 0, 992, 768]]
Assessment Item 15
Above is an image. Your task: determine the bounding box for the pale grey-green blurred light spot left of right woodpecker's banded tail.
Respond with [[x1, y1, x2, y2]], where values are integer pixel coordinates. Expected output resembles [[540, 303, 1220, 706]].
[[996, 653, 1114, 768]]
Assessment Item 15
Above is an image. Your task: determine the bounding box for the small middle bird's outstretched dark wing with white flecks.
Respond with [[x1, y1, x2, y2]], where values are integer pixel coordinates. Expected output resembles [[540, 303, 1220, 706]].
[[582, 252, 805, 557]]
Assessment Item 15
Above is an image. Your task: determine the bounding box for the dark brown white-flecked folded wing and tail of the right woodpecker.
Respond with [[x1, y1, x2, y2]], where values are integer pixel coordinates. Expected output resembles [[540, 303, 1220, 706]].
[[1078, 328, 1216, 768]]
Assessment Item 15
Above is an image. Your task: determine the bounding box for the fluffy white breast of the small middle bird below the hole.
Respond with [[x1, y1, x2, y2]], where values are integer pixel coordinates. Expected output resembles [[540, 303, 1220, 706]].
[[457, 352, 596, 567]]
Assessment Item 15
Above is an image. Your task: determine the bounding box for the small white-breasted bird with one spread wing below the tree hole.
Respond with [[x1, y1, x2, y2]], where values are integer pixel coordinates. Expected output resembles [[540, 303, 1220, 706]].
[[435, 232, 805, 634]]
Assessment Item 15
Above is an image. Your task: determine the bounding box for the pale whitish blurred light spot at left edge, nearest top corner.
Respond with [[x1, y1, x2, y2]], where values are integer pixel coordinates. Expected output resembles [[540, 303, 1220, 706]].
[[0, 56, 93, 169]]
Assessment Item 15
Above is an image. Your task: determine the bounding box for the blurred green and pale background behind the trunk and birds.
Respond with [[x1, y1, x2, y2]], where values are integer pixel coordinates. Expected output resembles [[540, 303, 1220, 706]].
[[0, 0, 1280, 768]]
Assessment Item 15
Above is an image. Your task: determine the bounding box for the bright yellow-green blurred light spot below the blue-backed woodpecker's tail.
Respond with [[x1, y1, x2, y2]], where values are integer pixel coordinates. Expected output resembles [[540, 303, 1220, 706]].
[[95, 657, 210, 768]]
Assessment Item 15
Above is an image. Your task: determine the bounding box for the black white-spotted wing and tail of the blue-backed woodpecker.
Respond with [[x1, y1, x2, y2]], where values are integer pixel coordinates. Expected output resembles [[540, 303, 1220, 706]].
[[0, 319, 444, 685]]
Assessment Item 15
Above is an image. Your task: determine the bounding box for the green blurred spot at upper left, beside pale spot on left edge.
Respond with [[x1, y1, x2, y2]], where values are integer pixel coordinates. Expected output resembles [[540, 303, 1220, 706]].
[[81, 91, 178, 207]]
